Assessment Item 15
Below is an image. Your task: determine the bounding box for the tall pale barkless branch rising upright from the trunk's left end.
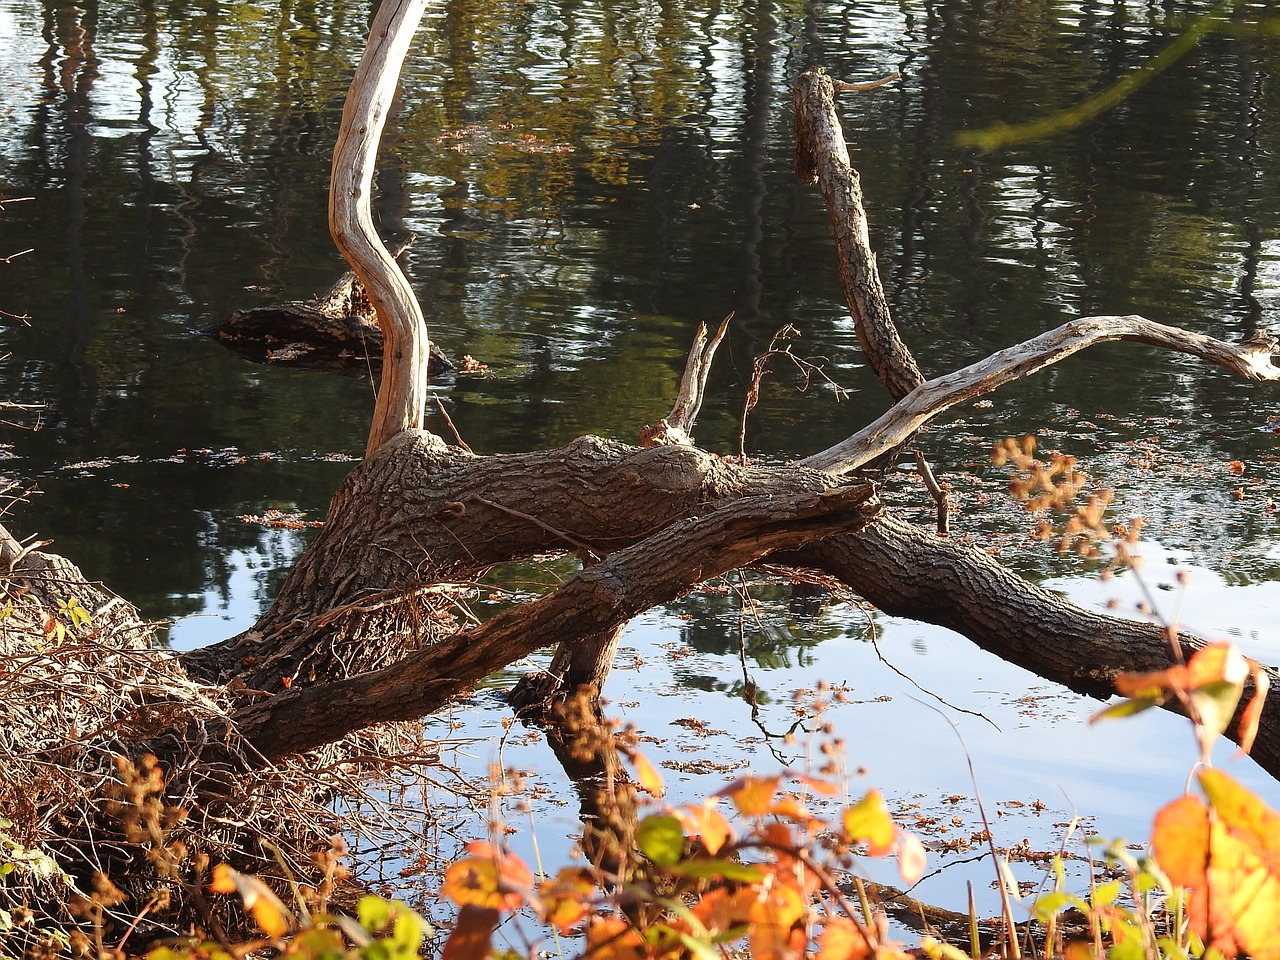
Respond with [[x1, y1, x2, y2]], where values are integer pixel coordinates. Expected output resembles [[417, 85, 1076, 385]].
[[329, 0, 429, 456]]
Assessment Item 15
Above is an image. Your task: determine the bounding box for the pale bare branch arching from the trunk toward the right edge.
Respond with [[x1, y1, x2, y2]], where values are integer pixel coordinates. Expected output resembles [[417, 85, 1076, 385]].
[[799, 315, 1280, 474]]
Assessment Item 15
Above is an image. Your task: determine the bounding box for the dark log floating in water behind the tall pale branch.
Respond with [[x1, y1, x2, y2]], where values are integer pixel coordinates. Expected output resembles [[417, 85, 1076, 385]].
[[201, 244, 453, 378]]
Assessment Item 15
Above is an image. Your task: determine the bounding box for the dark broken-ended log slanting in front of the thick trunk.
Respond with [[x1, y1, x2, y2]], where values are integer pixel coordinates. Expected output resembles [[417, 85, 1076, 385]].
[[227, 484, 879, 756]]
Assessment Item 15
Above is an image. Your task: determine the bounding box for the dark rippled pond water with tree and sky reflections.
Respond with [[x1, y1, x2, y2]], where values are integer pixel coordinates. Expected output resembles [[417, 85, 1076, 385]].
[[0, 0, 1280, 936]]
